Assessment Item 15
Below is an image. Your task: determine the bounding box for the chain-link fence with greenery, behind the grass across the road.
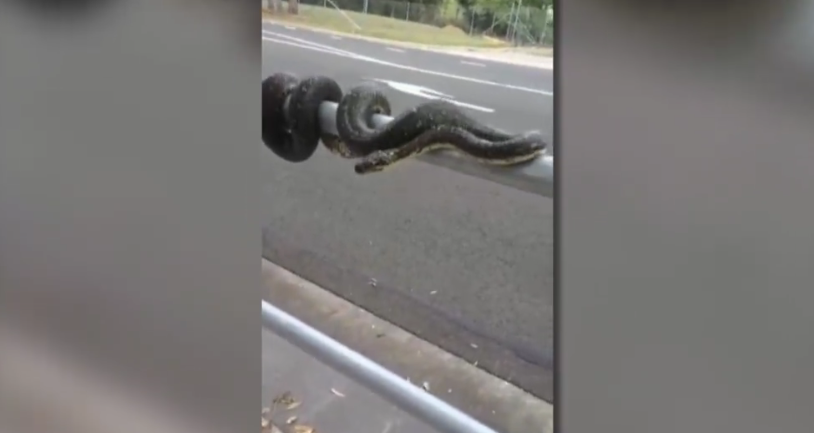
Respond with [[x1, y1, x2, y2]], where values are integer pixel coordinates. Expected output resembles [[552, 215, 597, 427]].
[[264, 0, 554, 46]]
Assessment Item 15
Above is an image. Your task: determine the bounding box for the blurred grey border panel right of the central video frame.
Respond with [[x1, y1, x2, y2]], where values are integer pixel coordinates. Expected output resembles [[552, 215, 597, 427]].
[[555, 0, 814, 433]]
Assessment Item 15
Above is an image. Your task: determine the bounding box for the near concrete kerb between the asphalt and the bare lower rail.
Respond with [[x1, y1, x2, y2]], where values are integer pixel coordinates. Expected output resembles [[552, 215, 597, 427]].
[[262, 260, 554, 433]]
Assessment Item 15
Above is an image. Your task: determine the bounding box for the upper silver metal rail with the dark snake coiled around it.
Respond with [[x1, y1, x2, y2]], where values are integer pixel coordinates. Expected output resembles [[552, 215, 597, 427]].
[[319, 102, 554, 198]]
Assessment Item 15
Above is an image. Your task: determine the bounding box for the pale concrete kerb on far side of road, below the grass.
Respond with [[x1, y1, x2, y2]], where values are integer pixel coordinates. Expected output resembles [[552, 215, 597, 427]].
[[263, 13, 554, 71]]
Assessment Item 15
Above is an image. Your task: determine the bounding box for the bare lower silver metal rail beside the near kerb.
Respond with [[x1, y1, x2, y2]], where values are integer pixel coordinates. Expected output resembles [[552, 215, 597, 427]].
[[261, 301, 496, 433]]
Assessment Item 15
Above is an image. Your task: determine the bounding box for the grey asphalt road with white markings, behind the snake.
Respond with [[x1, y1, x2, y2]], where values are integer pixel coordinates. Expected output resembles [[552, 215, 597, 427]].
[[261, 24, 553, 399]]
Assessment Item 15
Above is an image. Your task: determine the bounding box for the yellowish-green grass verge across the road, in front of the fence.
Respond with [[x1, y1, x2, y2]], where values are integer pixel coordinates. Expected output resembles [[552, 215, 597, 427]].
[[263, 2, 508, 48]]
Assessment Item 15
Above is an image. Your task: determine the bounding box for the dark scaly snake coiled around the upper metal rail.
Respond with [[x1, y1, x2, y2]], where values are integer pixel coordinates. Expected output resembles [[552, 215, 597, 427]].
[[262, 73, 547, 174]]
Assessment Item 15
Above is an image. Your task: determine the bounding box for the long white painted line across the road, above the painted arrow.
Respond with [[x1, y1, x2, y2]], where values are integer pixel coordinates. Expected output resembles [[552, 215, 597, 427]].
[[263, 30, 554, 96]]
